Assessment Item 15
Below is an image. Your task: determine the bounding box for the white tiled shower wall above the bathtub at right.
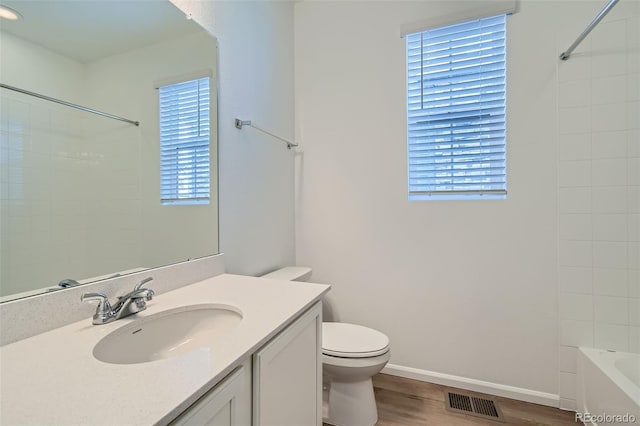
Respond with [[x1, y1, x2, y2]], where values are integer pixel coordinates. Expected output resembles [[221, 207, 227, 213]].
[[558, 2, 640, 409]]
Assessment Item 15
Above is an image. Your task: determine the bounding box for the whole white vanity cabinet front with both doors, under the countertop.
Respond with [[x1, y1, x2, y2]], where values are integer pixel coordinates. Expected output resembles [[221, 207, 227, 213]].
[[171, 302, 322, 426]]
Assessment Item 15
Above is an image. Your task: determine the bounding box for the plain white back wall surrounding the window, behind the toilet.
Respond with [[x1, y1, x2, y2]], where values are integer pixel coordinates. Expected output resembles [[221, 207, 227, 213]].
[[295, 1, 564, 395]]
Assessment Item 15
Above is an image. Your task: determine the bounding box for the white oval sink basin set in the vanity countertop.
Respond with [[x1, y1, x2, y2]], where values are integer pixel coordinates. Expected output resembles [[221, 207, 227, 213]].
[[93, 305, 242, 364]]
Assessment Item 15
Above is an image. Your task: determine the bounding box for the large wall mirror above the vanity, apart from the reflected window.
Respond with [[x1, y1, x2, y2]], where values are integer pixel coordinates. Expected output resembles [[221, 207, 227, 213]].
[[0, 0, 218, 302]]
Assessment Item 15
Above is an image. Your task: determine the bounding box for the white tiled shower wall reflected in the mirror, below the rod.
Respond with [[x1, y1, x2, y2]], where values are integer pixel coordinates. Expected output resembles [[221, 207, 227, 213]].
[[0, 89, 139, 295]]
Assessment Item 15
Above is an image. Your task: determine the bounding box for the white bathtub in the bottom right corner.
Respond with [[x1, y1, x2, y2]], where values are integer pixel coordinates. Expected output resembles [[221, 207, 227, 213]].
[[576, 348, 640, 425]]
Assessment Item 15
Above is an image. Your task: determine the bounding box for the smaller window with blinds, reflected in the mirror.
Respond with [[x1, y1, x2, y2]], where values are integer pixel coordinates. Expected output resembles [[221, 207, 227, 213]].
[[158, 77, 211, 204]]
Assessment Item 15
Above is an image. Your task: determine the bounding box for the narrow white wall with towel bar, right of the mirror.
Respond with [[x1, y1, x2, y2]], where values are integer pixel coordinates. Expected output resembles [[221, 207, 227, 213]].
[[172, 0, 295, 275]]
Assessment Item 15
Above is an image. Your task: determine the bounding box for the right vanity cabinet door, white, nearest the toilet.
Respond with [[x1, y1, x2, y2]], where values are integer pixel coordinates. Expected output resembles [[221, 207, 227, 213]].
[[253, 302, 322, 426]]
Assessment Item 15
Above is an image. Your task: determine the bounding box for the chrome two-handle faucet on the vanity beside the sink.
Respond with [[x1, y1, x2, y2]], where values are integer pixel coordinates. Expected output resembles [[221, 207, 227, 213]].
[[80, 277, 155, 324]]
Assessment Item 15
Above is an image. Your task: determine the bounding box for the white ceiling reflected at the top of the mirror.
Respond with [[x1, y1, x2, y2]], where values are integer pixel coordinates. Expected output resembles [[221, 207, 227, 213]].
[[0, 0, 201, 63]]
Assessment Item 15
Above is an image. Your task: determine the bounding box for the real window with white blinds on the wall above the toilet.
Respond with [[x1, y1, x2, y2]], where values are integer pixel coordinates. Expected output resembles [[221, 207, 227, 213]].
[[406, 15, 506, 200]]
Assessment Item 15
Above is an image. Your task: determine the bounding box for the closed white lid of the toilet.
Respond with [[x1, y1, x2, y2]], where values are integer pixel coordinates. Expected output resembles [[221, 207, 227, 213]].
[[322, 322, 389, 358]]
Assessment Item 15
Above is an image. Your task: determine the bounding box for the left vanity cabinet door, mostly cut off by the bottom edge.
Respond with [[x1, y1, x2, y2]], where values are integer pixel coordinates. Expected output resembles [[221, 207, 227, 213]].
[[171, 361, 251, 426]]
